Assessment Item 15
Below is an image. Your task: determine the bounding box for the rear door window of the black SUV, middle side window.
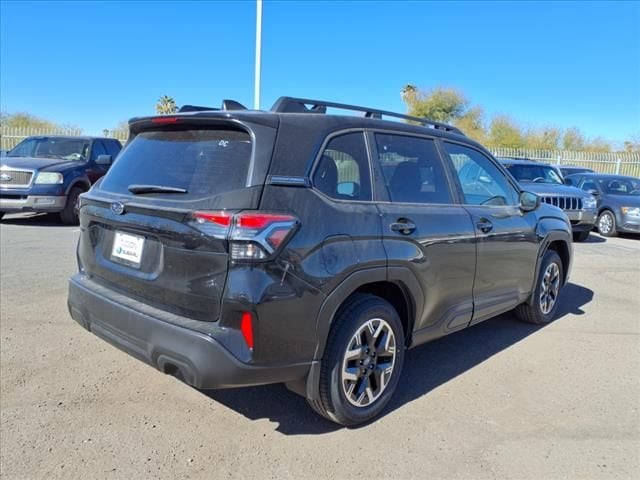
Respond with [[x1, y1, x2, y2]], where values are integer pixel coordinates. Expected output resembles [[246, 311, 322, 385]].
[[376, 134, 453, 204]]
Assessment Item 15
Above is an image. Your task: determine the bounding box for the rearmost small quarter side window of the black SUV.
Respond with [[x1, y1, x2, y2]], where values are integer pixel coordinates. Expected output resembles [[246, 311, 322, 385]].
[[313, 132, 371, 200]]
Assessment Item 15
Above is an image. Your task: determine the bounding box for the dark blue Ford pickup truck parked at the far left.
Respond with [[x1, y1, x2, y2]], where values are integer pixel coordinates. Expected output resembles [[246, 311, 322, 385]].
[[0, 136, 122, 224]]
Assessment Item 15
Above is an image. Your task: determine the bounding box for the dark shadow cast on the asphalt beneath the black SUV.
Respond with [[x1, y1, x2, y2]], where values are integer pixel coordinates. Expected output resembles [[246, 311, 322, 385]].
[[201, 283, 593, 435]]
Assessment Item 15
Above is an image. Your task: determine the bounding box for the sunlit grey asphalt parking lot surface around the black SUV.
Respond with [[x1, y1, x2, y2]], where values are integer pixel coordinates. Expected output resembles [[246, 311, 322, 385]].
[[0, 215, 640, 479]]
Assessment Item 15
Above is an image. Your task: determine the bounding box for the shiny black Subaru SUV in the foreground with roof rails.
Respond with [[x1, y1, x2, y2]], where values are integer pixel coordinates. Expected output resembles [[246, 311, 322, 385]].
[[68, 97, 572, 425]]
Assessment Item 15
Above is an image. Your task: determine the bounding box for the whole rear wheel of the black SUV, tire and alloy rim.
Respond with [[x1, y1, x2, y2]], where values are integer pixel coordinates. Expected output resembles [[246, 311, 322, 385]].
[[308, 294, 405, 426]]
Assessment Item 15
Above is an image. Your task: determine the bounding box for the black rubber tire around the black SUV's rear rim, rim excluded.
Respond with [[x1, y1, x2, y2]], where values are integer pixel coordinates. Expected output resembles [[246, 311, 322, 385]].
[[324, 295, 405, 425]]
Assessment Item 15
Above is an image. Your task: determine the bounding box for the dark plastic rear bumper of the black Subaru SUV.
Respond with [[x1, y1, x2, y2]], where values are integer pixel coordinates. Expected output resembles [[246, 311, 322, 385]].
[[68, 274, 310, 389]]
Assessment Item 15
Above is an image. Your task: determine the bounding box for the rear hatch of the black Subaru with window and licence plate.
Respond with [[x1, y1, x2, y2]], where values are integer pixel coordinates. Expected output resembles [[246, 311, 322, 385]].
[[78, 116, 276, 321]]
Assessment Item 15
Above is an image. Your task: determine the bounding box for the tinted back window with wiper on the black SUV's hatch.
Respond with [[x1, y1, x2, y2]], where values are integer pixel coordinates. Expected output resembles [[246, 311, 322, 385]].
[[101, 130, 251, 200]]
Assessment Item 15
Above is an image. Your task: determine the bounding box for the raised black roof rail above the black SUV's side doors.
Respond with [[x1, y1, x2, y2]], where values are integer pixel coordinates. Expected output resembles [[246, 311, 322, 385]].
[[271, 97, 464, 135]]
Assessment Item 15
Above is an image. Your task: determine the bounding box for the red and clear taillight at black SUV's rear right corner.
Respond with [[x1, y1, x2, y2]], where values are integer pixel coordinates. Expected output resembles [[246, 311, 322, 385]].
[[189, 211, 299, 260]]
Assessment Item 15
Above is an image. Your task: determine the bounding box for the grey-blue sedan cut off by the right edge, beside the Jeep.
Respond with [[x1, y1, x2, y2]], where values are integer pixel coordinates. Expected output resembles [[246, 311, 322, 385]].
[[567, 173, 640, 237]]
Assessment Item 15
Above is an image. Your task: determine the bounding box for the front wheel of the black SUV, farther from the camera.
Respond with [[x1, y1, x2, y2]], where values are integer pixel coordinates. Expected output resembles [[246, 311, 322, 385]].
[[515, 250, 564, 325]]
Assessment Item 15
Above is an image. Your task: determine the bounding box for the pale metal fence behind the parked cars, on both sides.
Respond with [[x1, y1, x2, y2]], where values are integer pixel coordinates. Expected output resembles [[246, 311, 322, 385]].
[[0, 127, 640, 177]]
